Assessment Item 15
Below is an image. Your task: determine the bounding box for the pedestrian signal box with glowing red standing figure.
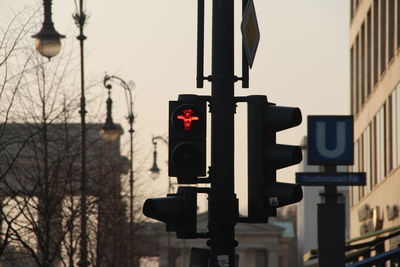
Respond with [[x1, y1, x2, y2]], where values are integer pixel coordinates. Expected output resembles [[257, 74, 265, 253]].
[[168, 95, 207, 183]]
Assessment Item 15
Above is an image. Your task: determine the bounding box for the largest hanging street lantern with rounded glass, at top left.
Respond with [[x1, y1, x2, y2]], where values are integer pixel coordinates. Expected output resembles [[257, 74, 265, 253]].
[[32, 0, 65, 60]]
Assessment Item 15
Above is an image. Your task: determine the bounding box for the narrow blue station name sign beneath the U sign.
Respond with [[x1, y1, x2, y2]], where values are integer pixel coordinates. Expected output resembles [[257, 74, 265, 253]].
[[296, 172, 366, 186]]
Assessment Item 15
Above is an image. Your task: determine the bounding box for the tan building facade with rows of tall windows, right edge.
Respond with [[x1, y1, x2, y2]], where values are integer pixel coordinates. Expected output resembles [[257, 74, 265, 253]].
[[350, 0, 400, 256]]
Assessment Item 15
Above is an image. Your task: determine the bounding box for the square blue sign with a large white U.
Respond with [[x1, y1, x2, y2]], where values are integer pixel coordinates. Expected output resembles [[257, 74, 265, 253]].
[[307, 116, 354, 165]]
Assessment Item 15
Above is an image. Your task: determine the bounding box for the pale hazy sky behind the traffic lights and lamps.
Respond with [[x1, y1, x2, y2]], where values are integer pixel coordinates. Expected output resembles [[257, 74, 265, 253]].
[[0, 0, 350, 214]]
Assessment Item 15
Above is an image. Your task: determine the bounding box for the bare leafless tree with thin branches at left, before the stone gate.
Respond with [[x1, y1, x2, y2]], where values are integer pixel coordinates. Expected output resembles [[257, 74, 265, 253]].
[[0, 7, 127, 266]]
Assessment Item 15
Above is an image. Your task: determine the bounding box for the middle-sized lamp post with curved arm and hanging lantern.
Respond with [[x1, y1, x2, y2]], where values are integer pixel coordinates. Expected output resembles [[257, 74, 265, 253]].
[[100, 75, 135, 266]]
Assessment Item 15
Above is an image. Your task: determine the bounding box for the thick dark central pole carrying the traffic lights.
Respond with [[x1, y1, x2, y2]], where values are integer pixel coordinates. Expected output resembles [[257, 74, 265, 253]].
[[207, 0, 238, 267]]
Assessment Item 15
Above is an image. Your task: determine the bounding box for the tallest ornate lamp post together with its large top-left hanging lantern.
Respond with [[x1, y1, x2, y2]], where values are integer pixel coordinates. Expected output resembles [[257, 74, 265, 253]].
[[32, 0, 89, 267]]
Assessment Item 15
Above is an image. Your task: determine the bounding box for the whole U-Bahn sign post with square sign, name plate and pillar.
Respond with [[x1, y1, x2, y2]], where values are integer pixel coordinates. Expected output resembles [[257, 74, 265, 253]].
[[296, 116, 365, 267]]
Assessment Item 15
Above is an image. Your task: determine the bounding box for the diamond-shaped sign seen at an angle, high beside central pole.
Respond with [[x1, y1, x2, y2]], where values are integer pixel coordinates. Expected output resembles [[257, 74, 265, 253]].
[[240, 0, 260, 68]]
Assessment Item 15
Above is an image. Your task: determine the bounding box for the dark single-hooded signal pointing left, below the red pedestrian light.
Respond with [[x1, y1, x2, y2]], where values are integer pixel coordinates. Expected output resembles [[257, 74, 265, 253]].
[[143, 186, 197, 238]]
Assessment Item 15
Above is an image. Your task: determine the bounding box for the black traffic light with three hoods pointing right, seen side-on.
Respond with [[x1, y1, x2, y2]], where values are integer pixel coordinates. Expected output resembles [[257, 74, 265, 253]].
[[247, 95, 303, 222]]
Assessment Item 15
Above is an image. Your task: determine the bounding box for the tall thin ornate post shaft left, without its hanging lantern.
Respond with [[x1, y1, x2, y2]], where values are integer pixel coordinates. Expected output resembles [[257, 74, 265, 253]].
[[74, 0, 89, 267]]
